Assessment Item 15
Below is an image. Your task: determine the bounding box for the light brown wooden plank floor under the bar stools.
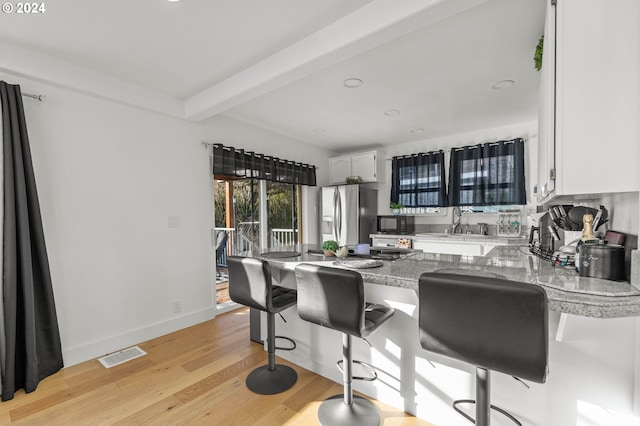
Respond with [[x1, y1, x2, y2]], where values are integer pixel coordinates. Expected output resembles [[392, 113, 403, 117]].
[[0, 308, 436, 426]]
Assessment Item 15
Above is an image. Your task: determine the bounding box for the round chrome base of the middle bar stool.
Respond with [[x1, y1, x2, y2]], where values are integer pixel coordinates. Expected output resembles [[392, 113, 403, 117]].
[[318, 395, 380, 426]]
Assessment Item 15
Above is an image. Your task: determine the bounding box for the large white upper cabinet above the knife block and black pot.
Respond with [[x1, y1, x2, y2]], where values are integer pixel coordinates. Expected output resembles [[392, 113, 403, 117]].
[[538, 0, 640, 203]]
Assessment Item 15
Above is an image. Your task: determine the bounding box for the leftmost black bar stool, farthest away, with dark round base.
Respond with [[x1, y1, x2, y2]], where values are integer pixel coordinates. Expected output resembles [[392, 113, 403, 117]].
[[227, 256, 298, 395]]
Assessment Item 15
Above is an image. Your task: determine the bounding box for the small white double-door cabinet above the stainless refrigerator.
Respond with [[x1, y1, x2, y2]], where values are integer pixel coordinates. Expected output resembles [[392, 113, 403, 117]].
[[329, 151, 384, 185]]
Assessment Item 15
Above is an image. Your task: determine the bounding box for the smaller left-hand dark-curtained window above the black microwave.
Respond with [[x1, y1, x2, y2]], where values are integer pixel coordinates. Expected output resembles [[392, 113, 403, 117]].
[[391, 151, 447, 207]]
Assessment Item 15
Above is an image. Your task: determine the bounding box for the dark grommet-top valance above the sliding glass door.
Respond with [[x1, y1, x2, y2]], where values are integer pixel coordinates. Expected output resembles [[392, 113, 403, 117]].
[[213, 144, 316, 186]]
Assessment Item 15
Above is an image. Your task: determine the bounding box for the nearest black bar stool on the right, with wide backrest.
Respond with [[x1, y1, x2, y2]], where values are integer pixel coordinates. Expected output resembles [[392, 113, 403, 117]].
[[418, 273, 549, 426]]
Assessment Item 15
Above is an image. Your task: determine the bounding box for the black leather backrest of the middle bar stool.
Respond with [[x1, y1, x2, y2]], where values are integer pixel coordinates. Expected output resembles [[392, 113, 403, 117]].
[[296, 263, 365, 337]]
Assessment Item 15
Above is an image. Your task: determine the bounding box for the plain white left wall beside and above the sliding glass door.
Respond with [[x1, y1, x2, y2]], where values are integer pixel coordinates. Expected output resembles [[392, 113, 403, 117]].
[[0, 73, 328, 366]]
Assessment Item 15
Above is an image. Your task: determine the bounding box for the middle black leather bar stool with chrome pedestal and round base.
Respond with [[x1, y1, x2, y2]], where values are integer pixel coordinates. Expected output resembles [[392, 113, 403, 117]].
[[296, 263, 393, 426]]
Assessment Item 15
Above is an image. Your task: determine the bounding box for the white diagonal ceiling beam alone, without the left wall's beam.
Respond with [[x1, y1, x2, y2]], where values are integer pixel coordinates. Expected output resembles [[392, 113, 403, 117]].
[[185, 0, 487, 121]]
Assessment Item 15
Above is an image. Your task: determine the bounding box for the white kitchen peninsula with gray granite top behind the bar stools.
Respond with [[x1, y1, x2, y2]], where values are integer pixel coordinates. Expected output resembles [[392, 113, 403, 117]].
[[250, 244, 640, 425]]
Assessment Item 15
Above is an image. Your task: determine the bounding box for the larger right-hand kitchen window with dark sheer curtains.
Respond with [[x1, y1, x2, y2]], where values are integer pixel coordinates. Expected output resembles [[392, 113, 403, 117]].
[[449, 139, 527, 206]]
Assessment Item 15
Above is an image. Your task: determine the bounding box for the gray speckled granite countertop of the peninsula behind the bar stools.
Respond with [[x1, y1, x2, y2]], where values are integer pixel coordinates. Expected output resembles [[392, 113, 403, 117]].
[[245, 245, 640, 318]]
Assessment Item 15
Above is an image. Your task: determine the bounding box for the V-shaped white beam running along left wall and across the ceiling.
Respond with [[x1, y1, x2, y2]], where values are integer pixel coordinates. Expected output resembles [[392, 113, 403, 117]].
[[0, 0, 488, 121]]
